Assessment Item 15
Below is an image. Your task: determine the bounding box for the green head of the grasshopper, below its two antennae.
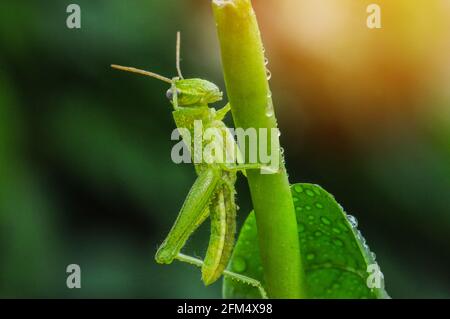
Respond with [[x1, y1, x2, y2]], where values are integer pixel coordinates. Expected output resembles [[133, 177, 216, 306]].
[[166, 79, 222, 107]]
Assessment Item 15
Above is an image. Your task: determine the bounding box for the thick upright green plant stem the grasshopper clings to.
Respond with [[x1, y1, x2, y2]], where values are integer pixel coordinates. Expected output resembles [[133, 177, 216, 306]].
[[213, 0, 305, 298]]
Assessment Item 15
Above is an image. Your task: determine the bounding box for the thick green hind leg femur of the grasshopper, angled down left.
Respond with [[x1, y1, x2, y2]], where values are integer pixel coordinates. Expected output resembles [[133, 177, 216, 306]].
[[155, 169, 220, 264]]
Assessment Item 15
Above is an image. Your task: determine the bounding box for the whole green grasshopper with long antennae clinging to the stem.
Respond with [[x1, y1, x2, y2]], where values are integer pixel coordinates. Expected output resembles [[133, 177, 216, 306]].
[[111, 33, 266, 297]]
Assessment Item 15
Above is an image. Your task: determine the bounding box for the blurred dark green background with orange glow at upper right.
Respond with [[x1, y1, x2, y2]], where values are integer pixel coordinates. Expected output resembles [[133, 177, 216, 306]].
[[0, 0, 450, 298]]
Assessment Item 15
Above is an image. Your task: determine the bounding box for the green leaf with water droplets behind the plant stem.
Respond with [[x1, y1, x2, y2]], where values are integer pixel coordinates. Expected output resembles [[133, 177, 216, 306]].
[[223, 184, 388, 298]]
